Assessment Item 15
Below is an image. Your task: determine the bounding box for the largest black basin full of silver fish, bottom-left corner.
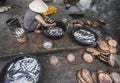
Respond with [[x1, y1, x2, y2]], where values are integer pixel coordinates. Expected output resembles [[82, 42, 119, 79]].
[[0, 55, 41, 83]]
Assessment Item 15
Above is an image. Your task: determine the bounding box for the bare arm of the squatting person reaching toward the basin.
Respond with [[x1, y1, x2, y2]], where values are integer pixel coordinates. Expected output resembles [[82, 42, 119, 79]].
[[35, 14, 56, 27]]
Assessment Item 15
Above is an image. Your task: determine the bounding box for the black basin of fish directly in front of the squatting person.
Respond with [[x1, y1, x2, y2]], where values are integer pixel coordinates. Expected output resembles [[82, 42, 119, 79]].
[[43, 21, 66, 39]]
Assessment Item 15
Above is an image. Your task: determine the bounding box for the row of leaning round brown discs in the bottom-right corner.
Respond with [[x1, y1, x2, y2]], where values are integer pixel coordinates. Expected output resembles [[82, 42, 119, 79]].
[[76, 69, 120, 83]]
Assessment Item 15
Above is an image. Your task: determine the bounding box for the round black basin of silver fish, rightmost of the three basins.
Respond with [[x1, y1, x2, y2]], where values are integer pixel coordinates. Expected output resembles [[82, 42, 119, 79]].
[[72, 28, 98, 45]]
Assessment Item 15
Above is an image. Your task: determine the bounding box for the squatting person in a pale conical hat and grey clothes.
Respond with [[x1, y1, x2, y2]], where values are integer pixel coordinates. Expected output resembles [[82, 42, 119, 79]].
[[24, 0, 56, 33]]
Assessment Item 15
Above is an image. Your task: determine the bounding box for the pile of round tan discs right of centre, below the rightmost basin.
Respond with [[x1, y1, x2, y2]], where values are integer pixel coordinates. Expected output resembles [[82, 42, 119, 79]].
[[83, 36, 118, 66]]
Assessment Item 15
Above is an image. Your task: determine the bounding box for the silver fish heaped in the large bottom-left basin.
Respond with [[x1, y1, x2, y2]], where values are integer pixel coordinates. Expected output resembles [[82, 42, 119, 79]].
[[5, 57, 41, 83]]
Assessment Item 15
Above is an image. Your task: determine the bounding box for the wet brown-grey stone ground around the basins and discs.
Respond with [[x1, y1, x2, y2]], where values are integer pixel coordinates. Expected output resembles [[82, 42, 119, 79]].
[[0, 2, 119, 83]]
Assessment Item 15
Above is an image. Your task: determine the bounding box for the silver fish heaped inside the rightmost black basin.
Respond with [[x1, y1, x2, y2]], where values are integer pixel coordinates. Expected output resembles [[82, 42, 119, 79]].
[[73, 29, 96, 44]]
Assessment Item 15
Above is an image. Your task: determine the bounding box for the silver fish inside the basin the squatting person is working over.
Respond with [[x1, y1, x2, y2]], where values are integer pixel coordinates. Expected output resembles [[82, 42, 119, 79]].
[[44, 26, 65, 37]]
